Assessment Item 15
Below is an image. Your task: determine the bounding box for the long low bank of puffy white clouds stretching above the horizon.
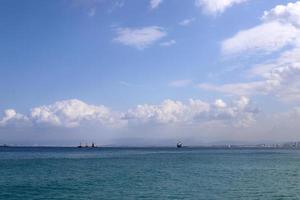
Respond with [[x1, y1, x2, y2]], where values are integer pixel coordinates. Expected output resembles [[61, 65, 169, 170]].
[[0, 97, 255, 129]]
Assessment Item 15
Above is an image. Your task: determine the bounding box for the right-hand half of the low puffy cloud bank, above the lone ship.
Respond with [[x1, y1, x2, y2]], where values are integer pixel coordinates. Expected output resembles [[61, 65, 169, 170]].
[[124, 97, 257, 126]]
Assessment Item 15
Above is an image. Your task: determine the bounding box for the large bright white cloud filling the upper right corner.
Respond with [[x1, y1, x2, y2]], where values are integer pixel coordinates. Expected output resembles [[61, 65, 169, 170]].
[[222, 2, 300, 54]]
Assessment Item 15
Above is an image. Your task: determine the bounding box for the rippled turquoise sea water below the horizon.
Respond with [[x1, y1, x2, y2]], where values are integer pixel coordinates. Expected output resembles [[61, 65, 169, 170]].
[[0, 148, 300, 200]]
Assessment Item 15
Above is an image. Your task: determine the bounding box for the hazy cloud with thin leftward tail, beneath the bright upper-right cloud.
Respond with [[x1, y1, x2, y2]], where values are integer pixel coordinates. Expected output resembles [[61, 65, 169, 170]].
[[198, 48, 300, 101]]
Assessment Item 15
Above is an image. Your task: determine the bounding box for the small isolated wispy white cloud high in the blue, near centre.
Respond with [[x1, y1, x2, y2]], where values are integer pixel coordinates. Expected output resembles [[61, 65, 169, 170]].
[[114, 26, 167, 49]]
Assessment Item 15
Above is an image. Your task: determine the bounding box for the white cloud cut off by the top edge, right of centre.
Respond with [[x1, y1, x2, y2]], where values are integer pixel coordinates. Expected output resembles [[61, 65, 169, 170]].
[[195, 0, 247, 15]]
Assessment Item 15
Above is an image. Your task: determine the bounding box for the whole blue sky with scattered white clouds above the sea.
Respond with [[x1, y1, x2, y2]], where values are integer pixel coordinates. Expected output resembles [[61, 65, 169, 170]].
[[0, 0, 300, 146]]
